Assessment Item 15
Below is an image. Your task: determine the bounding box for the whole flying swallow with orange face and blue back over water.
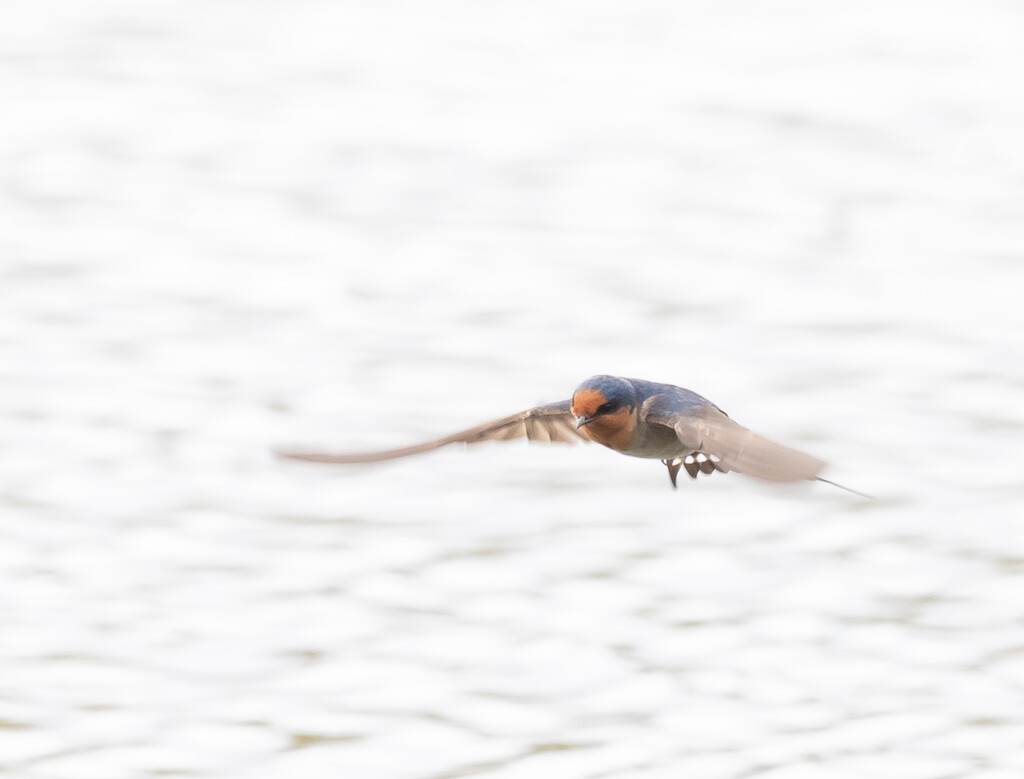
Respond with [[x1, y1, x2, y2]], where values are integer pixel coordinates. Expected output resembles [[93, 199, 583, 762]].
[[278, 376, 860, 494]]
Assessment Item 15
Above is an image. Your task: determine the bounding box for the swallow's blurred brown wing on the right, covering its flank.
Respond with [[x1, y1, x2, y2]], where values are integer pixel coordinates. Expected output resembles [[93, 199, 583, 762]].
[[644, 395, 825, 481]]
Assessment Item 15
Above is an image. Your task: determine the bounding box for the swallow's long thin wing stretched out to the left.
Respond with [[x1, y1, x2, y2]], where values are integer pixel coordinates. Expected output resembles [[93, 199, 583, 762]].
[[278, 400, 586, 465]]
